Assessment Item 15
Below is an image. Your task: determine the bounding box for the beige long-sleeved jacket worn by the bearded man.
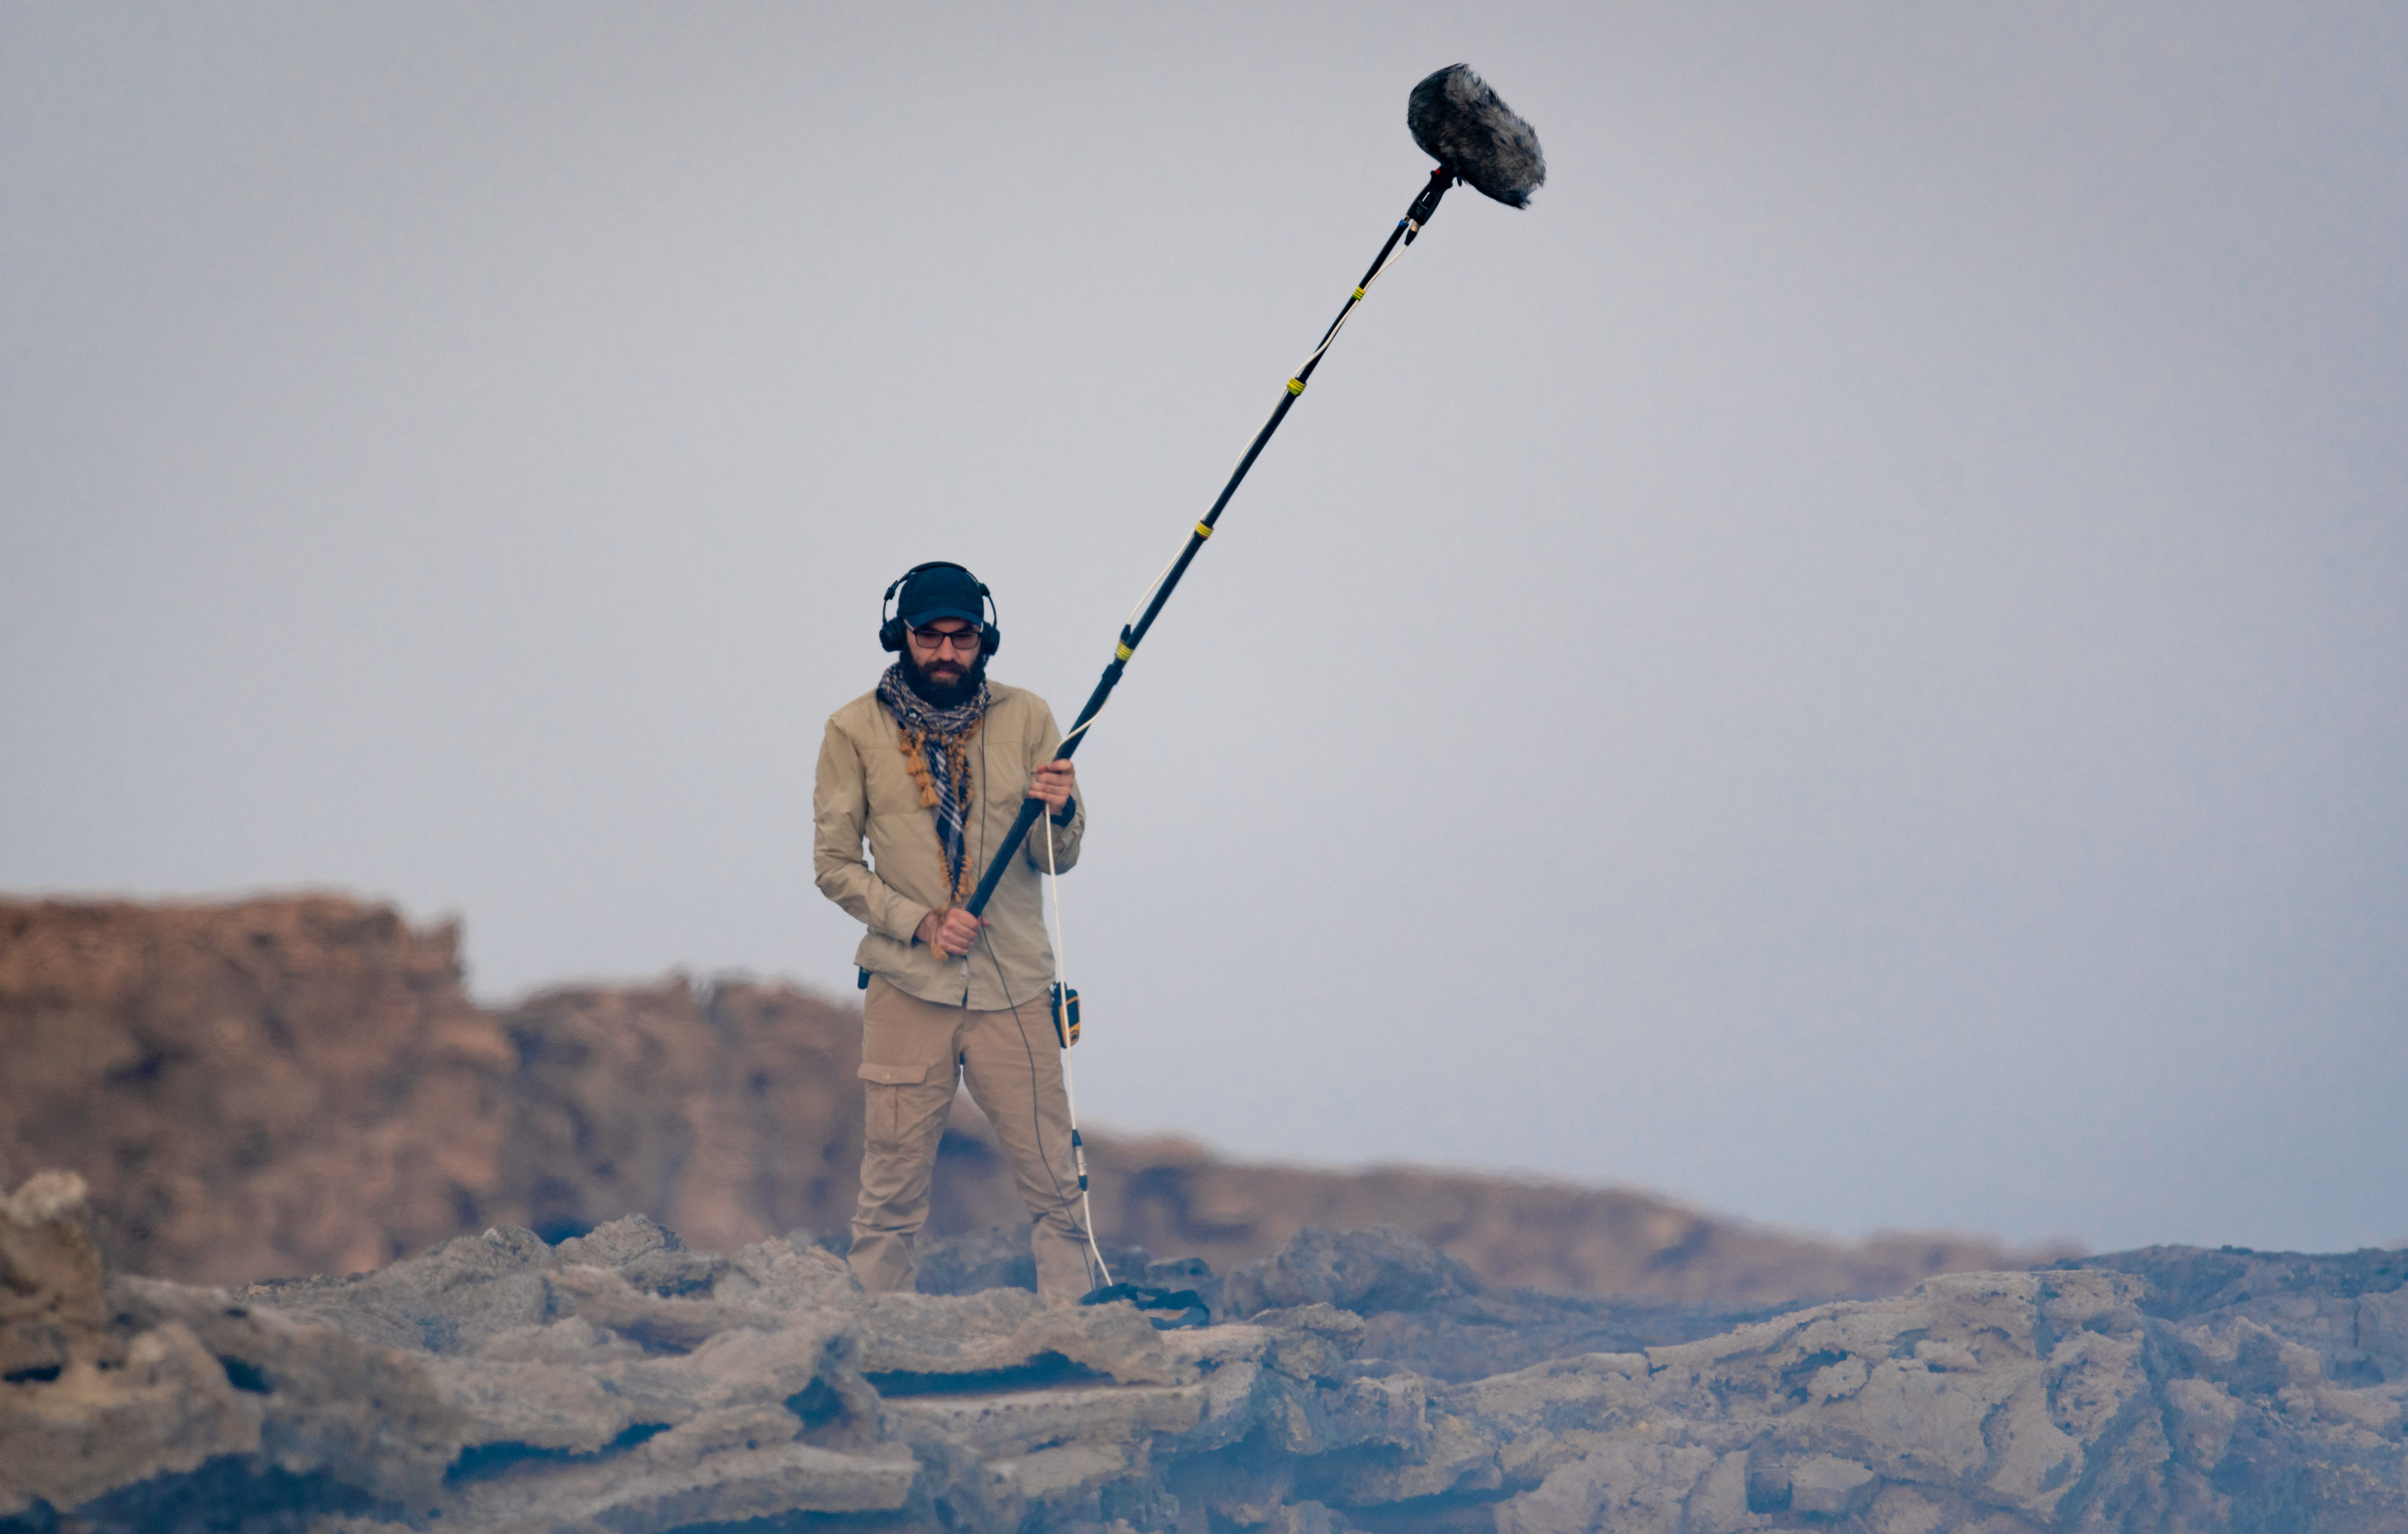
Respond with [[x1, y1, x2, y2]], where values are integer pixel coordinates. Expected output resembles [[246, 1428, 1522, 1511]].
[[811, 681, 1086, 1011]]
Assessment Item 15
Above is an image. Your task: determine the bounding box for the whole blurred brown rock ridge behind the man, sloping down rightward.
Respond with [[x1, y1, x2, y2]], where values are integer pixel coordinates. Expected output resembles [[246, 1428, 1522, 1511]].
[[0, 896, 2071, 1305]]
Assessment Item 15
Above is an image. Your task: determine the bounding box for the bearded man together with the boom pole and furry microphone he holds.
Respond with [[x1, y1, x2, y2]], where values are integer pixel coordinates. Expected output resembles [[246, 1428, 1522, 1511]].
[[814, 65, 1546, 1303]]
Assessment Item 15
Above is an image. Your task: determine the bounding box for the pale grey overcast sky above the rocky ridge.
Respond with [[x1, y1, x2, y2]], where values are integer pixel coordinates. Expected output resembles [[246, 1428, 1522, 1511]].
[[0, 0, 2408, 1248]]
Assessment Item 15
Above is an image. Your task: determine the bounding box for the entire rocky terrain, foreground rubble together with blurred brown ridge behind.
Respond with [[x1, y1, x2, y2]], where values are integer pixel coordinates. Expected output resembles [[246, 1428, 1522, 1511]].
[[0, 896, 2408, 1534]]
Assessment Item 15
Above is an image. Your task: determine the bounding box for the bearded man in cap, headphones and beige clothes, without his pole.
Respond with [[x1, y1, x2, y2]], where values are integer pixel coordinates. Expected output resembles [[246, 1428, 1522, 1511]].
[[811, 564, 1100, 1305]]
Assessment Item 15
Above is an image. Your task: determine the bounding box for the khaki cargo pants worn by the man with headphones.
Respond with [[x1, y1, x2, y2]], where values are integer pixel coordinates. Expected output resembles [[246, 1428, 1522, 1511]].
[[853, 976, 1103, 1305]]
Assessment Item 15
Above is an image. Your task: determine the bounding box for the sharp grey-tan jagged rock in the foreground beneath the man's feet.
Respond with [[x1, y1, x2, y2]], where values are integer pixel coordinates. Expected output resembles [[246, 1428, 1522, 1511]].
[[0, 1173, 2408, 1534]]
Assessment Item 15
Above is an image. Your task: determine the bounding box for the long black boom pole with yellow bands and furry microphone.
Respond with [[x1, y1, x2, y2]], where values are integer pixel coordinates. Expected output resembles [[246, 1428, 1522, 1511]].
[[963, 65, 1546, 915]]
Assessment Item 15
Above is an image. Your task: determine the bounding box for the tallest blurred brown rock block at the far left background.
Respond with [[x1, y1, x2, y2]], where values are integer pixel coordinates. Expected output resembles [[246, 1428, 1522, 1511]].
[[0, 896, 515, 1279]]
